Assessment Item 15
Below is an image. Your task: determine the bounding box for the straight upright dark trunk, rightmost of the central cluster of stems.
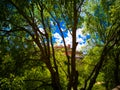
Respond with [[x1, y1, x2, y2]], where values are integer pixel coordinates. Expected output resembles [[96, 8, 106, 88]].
[[68, 0, 78, 90]]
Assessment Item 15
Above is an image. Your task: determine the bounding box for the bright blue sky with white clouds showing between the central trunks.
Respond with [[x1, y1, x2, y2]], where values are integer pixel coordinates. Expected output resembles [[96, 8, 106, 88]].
[[47, 21, 90, 51]]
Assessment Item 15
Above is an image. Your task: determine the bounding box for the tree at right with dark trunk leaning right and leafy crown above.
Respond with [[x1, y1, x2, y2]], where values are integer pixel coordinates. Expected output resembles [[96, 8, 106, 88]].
[[82, 0, 120, 90]]
